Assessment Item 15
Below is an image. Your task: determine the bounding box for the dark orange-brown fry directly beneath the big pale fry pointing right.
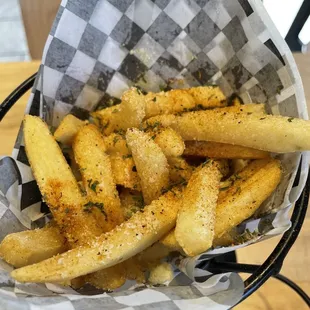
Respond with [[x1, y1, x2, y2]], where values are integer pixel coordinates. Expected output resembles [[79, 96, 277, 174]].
[[184, 141, 270, 159]]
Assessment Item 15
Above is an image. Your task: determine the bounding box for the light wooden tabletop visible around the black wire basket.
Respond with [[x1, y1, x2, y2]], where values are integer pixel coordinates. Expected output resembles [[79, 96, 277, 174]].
[[0, 54, 310, 310]]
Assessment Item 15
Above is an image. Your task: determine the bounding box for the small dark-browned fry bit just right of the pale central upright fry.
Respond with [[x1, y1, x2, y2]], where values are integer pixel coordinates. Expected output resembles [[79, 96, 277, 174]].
[[167, 157, 193, 184]]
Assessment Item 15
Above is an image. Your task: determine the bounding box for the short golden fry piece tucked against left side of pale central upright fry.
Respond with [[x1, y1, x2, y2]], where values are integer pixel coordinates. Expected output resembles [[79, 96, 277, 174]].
[[110, 154, 141, 191]]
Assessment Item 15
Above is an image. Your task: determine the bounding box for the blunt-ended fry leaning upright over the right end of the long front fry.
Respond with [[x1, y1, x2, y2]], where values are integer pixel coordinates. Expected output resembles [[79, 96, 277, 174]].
[[175, 161, 222, 256]]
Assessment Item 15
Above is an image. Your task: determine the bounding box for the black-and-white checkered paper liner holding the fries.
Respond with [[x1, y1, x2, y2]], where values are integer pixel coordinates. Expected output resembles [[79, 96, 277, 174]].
[[0, 0, 308, 309]]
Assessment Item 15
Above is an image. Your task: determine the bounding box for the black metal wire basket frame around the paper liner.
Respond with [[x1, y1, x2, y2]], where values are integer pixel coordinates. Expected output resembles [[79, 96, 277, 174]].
[[0, 74, 310, 307]]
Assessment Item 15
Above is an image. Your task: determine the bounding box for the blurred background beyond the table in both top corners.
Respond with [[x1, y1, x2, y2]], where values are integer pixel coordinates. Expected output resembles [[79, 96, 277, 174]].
[[0, 0, 310, 62]]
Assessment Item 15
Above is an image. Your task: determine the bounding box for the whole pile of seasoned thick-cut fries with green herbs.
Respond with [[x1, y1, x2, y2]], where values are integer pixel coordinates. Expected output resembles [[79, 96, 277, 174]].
[[0, 86, 310, 290]]
